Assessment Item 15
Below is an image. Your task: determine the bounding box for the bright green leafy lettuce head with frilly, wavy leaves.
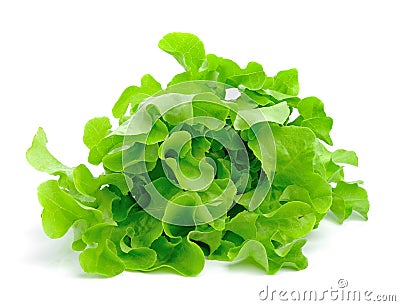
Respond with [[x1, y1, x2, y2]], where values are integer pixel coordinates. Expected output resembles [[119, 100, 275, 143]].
[[26, 33, 369, 277]]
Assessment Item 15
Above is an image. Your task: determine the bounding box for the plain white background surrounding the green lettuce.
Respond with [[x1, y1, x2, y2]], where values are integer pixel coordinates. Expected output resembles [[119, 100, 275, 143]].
[[0, 0, 400, 305]]
